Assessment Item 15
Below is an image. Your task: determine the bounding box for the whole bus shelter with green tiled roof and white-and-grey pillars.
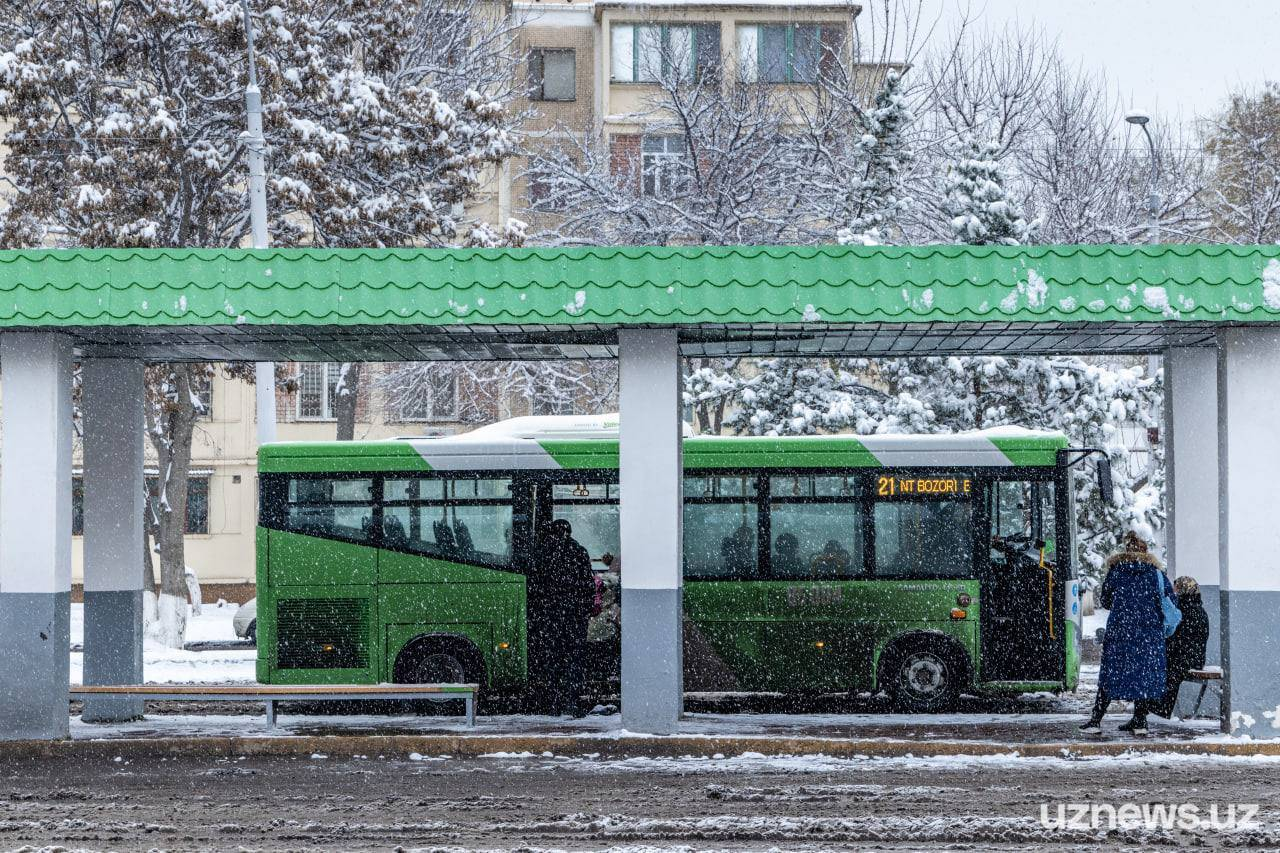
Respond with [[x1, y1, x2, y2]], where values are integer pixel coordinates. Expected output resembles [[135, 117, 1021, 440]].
[[0, 240, 1280, 739]]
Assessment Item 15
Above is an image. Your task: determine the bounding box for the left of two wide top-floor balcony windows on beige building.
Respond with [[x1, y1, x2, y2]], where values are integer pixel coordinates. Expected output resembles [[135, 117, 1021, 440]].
[[609, 24, 721, 83]]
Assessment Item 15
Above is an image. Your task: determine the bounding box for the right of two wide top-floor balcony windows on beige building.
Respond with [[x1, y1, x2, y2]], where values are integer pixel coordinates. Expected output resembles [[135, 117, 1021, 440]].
[[737, 24, 845, 83]]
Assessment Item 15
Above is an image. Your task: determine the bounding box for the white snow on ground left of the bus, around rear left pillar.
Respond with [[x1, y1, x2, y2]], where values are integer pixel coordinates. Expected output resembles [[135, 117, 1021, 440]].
[[70, 602, 257, 684]]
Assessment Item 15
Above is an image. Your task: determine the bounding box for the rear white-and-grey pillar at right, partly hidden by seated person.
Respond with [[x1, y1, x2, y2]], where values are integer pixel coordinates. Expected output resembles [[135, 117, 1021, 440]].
[[1164, 347, 1222, 716]]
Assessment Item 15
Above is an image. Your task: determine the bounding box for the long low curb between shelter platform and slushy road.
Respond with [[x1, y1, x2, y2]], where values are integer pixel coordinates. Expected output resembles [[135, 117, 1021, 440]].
[[0, 735, 1280, 760]]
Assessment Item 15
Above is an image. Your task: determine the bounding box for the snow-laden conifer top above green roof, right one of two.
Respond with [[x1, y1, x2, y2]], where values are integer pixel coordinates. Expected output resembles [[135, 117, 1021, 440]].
[[945, 136, 1036, 246]]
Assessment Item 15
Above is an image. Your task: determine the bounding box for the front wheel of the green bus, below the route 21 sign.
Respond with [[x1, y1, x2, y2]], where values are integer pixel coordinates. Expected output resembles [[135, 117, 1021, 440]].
[[878, 634, 969, 713]]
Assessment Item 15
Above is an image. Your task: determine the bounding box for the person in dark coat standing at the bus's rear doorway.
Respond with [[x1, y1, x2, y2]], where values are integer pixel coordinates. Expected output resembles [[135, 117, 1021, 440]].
[[526, 519, 595, 715]]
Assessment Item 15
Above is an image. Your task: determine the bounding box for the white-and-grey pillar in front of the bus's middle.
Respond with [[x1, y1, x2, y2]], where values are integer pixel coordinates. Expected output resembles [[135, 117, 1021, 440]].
[[618, 329, 684, 734]]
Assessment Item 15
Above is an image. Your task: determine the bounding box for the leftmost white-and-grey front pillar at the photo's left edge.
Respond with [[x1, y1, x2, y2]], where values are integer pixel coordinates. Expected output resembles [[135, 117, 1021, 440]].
[[0, 332, 72, 740]]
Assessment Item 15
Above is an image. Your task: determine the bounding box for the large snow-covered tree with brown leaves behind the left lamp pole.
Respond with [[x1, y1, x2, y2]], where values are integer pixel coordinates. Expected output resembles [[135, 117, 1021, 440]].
[[0, 0, 520, 644]]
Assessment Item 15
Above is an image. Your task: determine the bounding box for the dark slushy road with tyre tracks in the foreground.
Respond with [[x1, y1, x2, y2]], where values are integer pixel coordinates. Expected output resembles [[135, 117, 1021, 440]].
[[0, 754, 1280, 852]]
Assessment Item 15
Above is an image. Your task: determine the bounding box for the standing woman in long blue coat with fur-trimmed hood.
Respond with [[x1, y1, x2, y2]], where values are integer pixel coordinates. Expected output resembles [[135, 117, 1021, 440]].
[[1080, 533, 1174, 735]]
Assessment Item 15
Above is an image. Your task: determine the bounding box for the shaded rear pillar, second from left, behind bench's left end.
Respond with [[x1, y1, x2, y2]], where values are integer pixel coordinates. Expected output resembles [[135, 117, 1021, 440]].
[[82, 359, 145, 722]]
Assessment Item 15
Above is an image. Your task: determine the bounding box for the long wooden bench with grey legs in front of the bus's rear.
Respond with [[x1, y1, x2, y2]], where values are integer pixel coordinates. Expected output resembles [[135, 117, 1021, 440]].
[[70, 684, 479, 729]]
